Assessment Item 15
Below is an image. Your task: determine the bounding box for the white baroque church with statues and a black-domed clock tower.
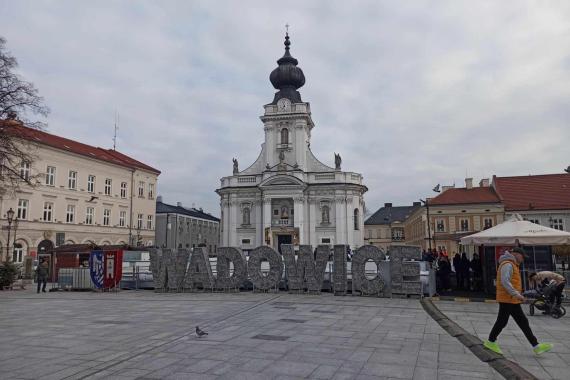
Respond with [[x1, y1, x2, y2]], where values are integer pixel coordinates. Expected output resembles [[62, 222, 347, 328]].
[[216, 34, 368, 252]]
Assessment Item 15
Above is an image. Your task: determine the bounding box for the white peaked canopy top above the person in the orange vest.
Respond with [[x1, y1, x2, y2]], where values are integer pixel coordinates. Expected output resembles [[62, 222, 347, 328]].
[[461, 215, 570, 245]]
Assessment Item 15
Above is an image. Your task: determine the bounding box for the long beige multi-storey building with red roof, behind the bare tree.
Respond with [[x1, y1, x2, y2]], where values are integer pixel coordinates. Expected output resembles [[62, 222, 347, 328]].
[[0, 121, 160, 262]]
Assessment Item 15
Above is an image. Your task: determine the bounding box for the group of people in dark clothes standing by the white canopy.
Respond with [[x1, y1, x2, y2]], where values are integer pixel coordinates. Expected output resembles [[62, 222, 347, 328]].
[[422, 248, 482, 292]]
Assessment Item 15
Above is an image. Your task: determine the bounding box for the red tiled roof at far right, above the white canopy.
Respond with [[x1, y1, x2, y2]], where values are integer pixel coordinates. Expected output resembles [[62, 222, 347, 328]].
[[493, 174, 570, 211]]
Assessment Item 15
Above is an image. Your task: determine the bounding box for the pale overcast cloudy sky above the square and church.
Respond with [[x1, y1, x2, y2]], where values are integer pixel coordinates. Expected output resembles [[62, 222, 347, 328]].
[[0, 0, 570, 216]]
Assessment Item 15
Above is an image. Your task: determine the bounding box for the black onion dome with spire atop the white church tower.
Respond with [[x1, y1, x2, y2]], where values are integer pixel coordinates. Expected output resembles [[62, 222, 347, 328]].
[[269, 34, 305, 104]]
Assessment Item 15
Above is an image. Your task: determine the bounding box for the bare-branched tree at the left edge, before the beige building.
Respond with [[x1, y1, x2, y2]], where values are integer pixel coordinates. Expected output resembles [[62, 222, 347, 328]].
[[0, 37, 49, 197]]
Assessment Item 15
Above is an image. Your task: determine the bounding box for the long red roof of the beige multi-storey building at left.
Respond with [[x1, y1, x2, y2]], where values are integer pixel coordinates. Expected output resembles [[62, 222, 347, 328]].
[[0, 120, 160, 174]]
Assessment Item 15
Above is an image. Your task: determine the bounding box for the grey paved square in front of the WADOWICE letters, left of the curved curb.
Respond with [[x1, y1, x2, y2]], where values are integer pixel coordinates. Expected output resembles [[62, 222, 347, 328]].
[[0, 291, 500, 380]]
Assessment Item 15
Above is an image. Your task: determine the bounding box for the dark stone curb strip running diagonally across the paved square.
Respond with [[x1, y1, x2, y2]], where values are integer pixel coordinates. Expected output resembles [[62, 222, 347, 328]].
[[420, 298, 538, 380]]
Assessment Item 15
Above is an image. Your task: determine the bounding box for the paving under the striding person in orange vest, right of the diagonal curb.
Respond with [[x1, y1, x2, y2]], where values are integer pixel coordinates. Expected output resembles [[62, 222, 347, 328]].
[[434, 301, 570, 380]]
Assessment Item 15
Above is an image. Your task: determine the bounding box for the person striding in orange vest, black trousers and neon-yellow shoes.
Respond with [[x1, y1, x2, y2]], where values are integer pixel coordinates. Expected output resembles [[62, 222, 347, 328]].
[[483, 247, 552, 355]]
